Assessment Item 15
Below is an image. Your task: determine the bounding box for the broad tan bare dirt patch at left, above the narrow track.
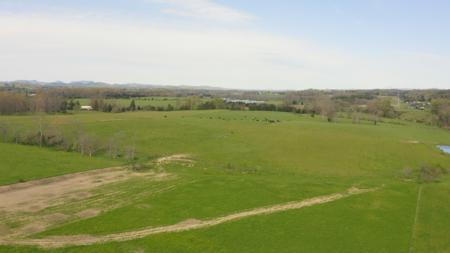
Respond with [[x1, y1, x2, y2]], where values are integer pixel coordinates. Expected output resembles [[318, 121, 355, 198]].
[[0, 164, 176, 240]]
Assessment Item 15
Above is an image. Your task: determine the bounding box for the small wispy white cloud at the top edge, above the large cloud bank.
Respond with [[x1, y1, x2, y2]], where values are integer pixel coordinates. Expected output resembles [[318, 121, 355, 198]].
[[147, 0, 255, 22]]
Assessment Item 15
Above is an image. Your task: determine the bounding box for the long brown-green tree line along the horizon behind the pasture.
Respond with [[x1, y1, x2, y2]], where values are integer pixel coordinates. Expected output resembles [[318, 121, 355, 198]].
[[0, 87, 450, 128]]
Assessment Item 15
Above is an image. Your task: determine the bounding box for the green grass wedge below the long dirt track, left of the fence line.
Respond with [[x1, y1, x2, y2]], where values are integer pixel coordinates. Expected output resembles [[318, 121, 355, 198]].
[[0, 185, 422, 253]]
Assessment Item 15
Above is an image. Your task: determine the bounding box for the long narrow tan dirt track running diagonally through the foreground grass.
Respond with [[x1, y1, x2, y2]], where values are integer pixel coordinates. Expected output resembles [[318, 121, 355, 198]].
[[0, 187, 378, 248]]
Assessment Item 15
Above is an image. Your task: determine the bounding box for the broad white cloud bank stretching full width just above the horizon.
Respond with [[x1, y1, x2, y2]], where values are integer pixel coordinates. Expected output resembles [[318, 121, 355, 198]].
[[0, 11, 450, 89]]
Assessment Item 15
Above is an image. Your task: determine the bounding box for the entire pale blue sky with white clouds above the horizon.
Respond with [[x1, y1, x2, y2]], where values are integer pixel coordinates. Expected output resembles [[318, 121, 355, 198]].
[[0, 0, 450, 90]]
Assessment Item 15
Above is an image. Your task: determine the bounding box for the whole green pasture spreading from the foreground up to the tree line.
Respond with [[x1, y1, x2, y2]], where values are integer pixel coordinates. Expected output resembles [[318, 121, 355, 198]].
[[0, 110, 450, 252]]
